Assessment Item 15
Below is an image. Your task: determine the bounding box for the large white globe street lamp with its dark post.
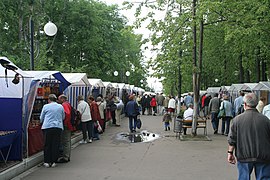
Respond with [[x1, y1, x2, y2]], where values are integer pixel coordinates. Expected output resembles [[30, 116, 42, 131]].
[[29, 20, 57, 70]]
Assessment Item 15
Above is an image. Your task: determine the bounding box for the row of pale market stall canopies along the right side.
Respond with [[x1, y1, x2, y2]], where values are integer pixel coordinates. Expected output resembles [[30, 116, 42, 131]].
[[206, 81, 270, 104]]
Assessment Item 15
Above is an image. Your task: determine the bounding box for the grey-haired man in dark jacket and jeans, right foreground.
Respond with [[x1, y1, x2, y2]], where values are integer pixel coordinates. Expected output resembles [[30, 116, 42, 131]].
[[228, 93, 270, 180]]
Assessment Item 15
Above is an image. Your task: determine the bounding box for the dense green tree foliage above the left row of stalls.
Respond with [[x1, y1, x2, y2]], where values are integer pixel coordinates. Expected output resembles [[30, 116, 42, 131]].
[[0, 0, 146, 86]]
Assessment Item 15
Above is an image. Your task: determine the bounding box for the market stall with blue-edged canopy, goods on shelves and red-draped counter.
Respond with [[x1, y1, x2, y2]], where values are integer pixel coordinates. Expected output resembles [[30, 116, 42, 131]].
[[25, 71, 70, 156]]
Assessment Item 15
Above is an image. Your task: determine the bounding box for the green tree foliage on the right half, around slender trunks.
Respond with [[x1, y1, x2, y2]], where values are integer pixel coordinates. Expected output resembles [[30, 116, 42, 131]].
[[127, 0, 270, 94]]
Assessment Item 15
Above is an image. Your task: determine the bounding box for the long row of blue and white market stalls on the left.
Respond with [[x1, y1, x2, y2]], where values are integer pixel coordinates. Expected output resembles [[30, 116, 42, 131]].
[[0, 57, 144, 163]]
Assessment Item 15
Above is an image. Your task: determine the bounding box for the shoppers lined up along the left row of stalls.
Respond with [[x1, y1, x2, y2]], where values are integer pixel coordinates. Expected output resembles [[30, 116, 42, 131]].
[[40, 94, 124, 167]]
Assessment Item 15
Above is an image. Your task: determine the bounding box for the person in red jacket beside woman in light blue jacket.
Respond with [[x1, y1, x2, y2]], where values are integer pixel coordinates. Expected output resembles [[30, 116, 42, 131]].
[[58, 95, 75, 163]]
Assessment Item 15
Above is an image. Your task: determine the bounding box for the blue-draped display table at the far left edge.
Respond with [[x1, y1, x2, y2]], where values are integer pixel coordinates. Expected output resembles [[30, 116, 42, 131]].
[[0, 131, 18, 164]]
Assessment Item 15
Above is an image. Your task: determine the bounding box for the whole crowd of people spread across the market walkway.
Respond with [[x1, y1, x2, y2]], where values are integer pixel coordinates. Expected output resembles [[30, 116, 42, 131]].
[[40, 92, 270, 179]]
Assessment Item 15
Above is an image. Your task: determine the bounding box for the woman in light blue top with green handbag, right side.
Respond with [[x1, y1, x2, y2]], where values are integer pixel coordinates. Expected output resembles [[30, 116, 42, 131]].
[[220, 95, 233, 136]]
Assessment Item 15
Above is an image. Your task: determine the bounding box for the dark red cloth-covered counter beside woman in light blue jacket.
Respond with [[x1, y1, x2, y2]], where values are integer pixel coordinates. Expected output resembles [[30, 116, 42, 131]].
[[28, 126, 44, 156]]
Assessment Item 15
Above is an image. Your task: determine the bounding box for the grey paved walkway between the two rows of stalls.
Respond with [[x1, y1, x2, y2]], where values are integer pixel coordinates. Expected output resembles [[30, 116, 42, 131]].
[[14, 116, 237, 180]]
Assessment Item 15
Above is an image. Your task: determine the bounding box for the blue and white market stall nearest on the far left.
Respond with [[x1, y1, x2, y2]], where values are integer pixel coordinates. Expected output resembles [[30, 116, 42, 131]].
[[0, 57, 32, 160]]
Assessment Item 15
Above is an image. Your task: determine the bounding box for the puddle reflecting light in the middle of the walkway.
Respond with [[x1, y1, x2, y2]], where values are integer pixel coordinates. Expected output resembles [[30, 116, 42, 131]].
[[116, 130, 160, 143]]
